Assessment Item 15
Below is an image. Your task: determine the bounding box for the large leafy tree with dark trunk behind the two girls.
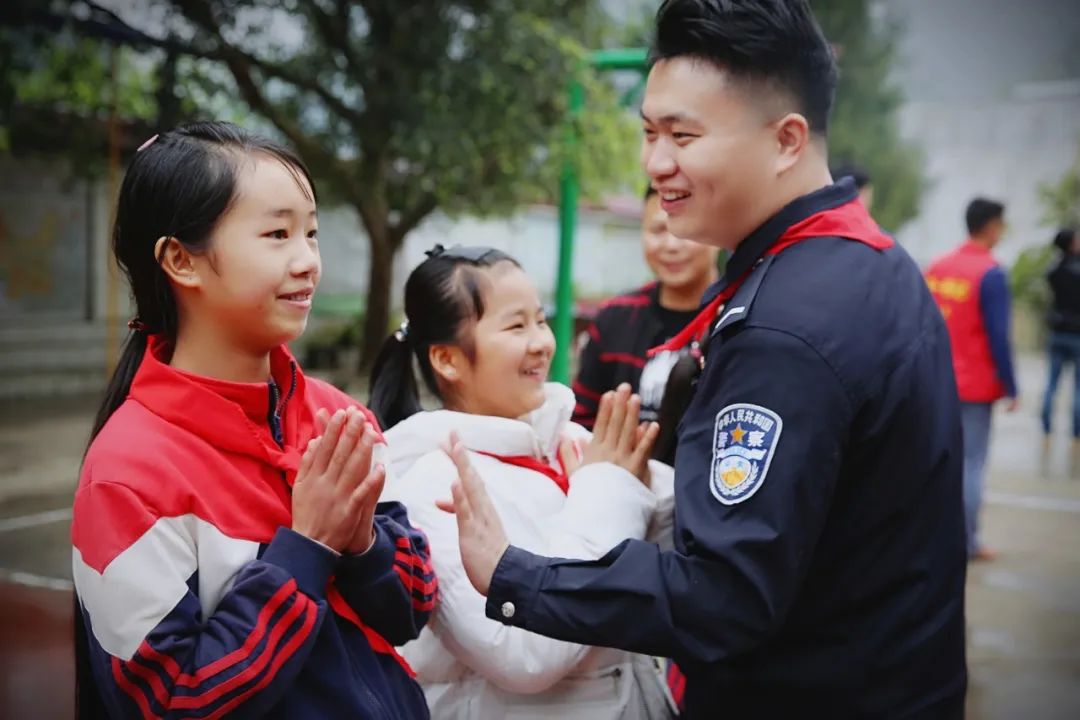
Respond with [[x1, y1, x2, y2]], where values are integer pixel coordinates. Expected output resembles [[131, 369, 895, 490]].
[[90, 0, 636, 369]]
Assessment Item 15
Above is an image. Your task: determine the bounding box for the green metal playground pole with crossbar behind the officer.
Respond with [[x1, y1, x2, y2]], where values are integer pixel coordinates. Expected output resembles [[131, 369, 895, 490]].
[[551, 47, 648, 384]]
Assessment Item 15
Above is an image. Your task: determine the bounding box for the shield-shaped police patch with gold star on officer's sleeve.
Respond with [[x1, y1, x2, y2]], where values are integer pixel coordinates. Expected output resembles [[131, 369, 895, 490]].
[[708, 403, 784, 505]]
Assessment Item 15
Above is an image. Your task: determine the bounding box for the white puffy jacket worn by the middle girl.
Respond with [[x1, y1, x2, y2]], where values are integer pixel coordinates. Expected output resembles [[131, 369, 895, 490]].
[[383, 383, 674, 720]]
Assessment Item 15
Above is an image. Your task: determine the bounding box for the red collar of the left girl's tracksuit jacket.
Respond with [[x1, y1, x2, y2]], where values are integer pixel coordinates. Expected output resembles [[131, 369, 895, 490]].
[[130, 335, 312, 472]]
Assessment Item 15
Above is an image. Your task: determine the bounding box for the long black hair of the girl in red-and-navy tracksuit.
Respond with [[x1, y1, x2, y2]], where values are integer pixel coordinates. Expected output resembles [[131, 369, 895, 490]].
[[75, 122, 315, 718]]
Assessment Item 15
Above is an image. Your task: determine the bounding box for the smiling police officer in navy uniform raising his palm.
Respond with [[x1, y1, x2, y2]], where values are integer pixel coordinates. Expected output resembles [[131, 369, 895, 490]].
[[438, 0, 967, 718]]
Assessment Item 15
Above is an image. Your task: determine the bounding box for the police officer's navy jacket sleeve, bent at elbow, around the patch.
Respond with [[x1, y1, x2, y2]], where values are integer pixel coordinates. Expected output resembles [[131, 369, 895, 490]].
[[487, 328, 854, 663]]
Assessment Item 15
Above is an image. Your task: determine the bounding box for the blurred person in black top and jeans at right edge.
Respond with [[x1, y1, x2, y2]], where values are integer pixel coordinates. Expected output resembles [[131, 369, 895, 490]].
[[1040, 228, 1080, 477]]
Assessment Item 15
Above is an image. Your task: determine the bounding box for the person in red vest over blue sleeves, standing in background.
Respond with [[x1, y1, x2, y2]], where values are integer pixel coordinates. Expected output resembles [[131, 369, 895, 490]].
[[927, 198, 1018, 560]]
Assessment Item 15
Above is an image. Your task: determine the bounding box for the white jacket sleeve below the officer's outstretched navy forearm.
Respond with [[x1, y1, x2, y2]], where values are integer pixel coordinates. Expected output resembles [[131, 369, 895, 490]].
[[394, 452, 626, 694]]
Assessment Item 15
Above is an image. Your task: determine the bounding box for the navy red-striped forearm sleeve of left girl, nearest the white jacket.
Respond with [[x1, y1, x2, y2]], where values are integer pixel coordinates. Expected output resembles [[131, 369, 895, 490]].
[[335, 502, 438, 646]]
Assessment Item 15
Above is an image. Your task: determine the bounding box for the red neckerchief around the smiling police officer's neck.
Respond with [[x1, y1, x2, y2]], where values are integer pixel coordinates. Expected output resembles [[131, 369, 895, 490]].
[[649, 200, 893, 357]]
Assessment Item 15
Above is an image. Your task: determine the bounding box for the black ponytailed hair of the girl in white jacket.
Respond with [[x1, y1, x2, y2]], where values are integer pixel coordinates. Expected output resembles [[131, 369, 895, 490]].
[[367, 245, 521, 429]]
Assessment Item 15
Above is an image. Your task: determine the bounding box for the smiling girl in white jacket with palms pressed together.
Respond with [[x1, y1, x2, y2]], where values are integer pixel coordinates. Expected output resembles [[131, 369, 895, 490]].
[[369, 246, 672, 720]]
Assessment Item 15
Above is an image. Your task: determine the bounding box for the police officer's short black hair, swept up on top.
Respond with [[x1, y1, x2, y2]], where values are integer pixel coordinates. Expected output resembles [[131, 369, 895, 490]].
[[649, 0, 837, 137]]
